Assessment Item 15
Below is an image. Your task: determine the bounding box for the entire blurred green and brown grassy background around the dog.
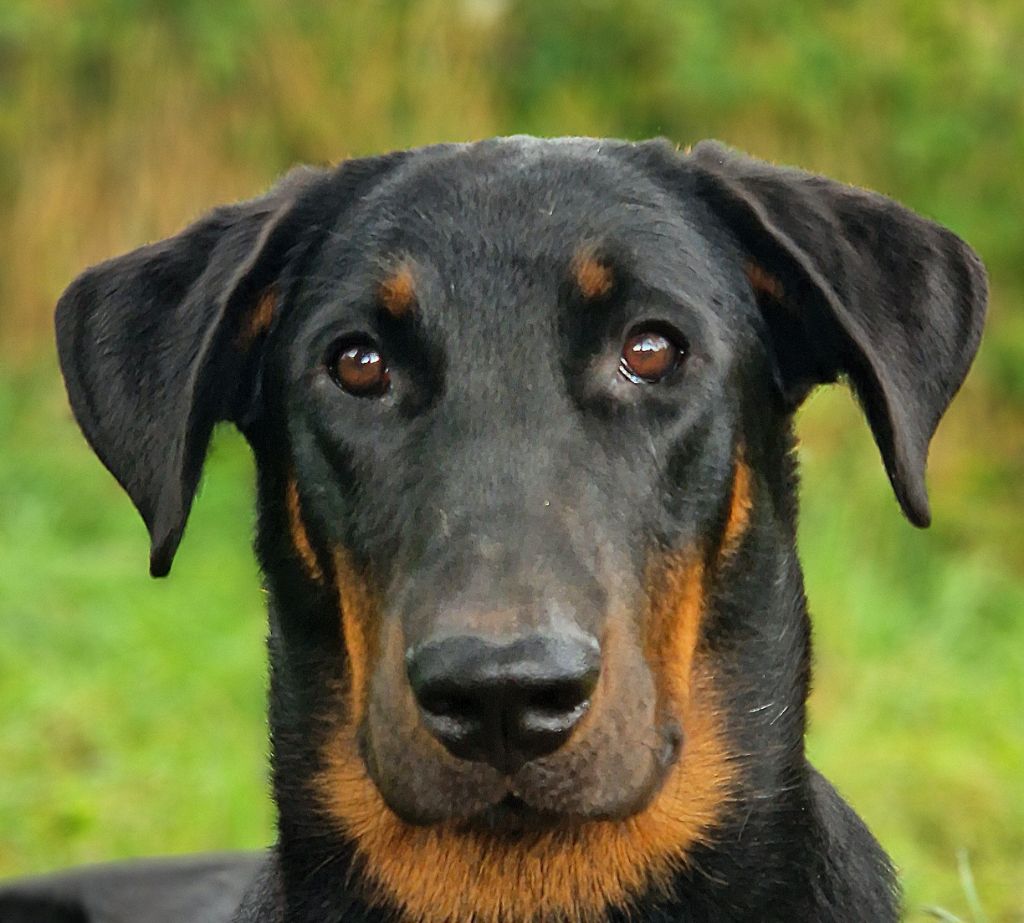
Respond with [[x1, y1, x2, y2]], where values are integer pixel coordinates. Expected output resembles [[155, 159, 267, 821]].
[[0, 0, 1024, 923]]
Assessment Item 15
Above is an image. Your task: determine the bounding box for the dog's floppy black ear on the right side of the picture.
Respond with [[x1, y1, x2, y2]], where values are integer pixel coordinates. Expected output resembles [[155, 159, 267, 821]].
[[690, 141, 987, 526]]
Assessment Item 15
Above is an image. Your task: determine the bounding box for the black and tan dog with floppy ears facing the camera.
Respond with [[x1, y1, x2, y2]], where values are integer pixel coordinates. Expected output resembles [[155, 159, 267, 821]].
[[0, 137, 987, 923]]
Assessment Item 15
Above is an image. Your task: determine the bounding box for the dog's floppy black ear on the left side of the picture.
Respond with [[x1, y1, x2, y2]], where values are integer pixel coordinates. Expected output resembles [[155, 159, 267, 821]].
[[56, 161, 329, 577]]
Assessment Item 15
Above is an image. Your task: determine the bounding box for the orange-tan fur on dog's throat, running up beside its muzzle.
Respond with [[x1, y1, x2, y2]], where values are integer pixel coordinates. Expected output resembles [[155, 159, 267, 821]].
[[316, 553, 734, 923]]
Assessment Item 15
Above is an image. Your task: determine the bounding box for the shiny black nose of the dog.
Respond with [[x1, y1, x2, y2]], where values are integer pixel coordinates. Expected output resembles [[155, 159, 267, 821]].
[[406, 635, 601, 773]]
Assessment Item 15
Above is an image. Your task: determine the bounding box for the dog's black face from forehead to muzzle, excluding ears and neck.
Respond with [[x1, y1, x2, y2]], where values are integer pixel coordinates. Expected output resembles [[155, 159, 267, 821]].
[[269, 144, 761, 824]]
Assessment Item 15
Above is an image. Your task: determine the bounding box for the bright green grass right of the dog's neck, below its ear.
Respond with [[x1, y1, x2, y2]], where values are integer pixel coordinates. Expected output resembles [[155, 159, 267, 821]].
[[800, 390, 1024, 921]]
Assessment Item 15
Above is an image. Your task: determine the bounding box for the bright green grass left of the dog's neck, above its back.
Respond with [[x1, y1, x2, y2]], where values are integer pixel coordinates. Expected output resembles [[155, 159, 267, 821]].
[[0, 369, 271, 874]]
